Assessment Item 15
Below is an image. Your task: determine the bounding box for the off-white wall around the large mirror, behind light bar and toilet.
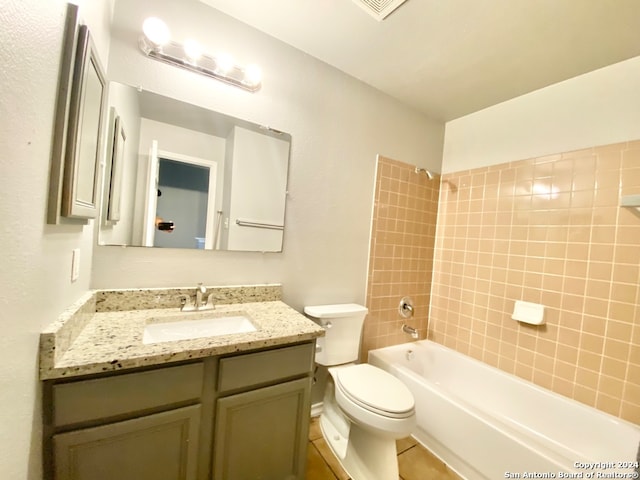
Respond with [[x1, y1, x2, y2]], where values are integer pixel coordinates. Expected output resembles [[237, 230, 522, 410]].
[[92, 0, 444, 308]]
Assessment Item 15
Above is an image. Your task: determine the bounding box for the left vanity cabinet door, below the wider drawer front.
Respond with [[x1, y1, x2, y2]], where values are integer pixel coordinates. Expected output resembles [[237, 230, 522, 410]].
[[53, 405, 200, 480]]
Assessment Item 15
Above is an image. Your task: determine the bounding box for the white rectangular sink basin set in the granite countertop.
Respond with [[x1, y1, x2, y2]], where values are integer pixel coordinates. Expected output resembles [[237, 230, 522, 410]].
[[142, 313, 257, 344]]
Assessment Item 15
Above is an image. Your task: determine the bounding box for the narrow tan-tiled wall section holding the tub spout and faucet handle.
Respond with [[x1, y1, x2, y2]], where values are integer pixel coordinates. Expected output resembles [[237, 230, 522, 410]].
[[362, 157, 440, 359]]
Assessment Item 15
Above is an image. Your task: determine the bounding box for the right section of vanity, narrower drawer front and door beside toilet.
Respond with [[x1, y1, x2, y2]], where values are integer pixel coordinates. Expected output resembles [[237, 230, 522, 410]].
[[213, 345, 313, 480]]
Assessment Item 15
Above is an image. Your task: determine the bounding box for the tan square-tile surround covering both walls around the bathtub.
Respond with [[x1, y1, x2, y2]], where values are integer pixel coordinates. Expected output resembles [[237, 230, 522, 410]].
[[363, 141, 640, 423]]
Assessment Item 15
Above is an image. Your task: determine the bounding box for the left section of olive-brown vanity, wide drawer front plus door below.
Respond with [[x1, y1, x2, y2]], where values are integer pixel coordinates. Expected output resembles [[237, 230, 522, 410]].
[[45, 362, 205, 480]]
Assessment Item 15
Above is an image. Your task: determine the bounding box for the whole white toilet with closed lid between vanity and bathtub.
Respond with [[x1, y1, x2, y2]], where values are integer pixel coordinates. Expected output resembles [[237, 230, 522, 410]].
[[304, 303, 416, 480]]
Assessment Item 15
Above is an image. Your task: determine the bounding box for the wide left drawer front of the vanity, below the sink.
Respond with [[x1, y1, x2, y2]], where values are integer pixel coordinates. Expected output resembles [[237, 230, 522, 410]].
[[53, 363, 204, 427]]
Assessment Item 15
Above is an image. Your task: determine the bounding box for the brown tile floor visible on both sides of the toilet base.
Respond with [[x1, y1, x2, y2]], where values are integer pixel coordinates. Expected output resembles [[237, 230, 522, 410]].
[[306, 417, 460, 480]]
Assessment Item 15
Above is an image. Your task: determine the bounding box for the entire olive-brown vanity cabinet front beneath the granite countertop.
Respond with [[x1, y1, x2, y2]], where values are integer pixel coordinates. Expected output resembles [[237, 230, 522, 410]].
[[44, 342, 314, 480]]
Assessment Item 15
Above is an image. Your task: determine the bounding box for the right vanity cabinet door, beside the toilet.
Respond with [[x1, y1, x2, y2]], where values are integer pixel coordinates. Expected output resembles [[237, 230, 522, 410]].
[[213, 378, 311, 480]]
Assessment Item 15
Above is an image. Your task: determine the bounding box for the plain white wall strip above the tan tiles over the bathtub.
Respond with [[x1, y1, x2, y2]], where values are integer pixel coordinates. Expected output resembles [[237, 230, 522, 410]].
[[442, 57, 640, 173]]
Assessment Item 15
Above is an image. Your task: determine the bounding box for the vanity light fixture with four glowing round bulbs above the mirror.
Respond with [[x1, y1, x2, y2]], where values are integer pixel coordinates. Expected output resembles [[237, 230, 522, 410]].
[[138, 17, 262, 92]]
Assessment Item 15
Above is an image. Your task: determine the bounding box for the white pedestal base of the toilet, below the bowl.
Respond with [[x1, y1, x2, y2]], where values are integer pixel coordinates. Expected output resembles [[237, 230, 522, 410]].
[[320, 415, 398, 480]]
